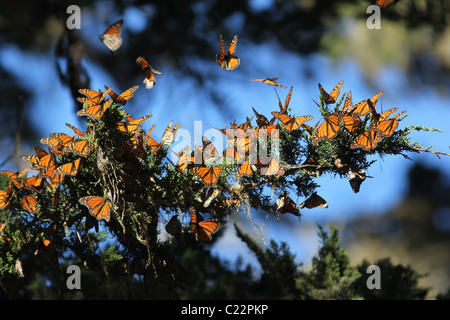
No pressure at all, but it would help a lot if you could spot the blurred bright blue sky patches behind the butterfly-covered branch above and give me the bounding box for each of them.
[0,7,450,265]
